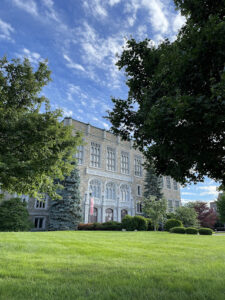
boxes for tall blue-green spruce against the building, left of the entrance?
[49,165,81,230]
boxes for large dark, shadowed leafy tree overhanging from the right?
[108,0,225,184]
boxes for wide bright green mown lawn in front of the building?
[0,231,225,300]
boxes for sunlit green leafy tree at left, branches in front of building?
[0,57,81,197]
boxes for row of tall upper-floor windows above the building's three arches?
[76,142,142,177]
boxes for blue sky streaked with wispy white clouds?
[0,0,218,204]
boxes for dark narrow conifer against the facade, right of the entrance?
[144,166,163,200]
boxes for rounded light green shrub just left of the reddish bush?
[175,206,198,227]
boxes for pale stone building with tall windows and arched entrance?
[28,118,181,230]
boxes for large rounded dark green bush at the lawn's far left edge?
[0,198,32,231]
